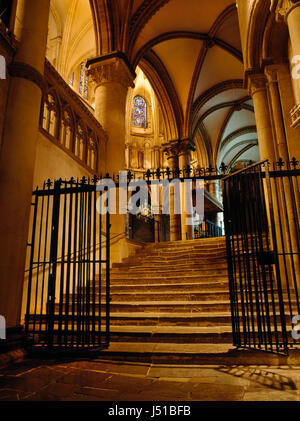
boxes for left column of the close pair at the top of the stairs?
[162,141,181,241]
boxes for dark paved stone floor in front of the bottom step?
[0,359,300,402]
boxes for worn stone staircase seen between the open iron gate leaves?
[101,238,244,361]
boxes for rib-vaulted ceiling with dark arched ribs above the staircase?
[51,0,259,171]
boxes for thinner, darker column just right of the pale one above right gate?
[265,65,289,162]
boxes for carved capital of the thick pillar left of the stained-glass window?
[87,52,136,89]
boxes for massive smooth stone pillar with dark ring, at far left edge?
[0,0,50,328]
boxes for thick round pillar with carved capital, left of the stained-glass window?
[87,52,135,262]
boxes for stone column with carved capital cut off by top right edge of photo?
[276,0,300,127]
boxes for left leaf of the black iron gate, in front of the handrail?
[25,177,110,349]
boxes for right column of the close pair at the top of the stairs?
[179,139,194,240]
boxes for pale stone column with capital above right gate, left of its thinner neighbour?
[248,74,275,162]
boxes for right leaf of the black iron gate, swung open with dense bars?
[224,160,300,354]
